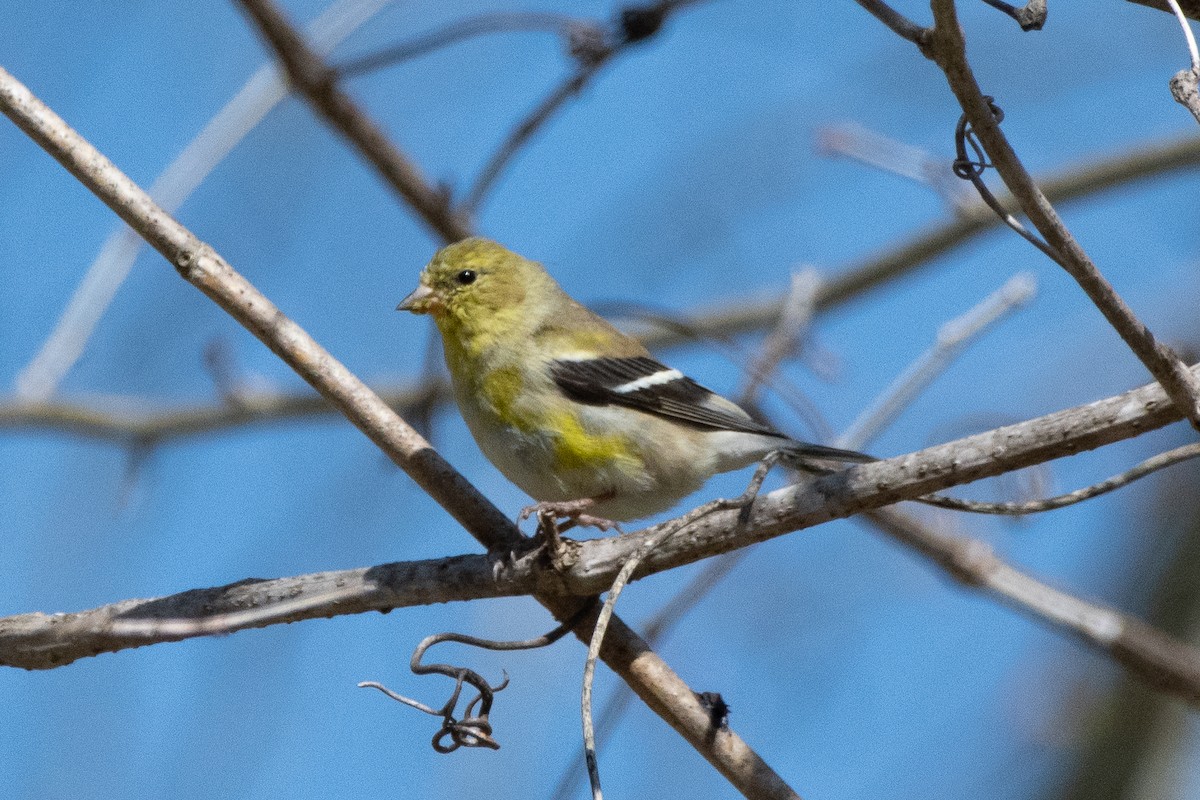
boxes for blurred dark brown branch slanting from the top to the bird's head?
[240,0,472,242]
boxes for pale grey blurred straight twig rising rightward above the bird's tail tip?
[836,272,1037,450]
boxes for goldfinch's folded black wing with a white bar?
[550,356,784,437]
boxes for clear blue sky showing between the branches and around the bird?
[0,0,1200,800]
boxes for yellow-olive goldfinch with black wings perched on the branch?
[397,237,872,527]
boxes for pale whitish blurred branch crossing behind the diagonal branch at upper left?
[16,0,390,401]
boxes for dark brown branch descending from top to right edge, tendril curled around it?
[926,0,1200,429]
